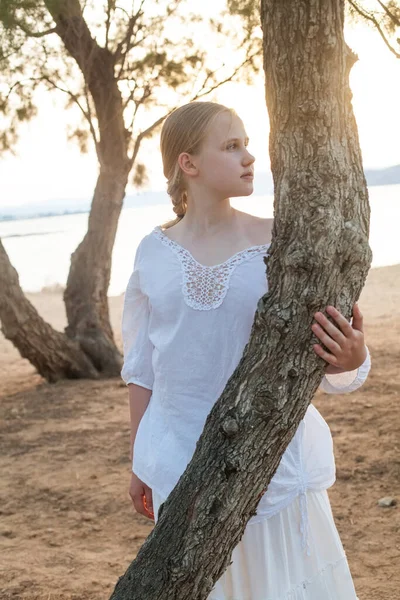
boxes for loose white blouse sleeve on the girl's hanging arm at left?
[121,244,154,390]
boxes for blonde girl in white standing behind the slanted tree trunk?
[122,102,370,600]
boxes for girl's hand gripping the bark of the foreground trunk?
[311,303,367,375]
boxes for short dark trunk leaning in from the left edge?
[0,241,98,382]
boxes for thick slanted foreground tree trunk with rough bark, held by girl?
[111,0,371,600]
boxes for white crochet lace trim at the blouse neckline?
[153,226,270,310]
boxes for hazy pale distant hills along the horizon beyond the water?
[0,165,400,221]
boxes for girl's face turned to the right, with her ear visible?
[182,112,255,199]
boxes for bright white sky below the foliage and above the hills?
[0,7,400,206]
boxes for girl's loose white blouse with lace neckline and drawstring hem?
[121,227,370,543]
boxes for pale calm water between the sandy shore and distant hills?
[0,185,400,296]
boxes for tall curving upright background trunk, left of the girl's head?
[45,0,132,376]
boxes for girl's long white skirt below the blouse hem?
[153,490,357,600]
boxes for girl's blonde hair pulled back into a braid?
[160,102,236,229]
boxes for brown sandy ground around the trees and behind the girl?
[0,265,400,600]
